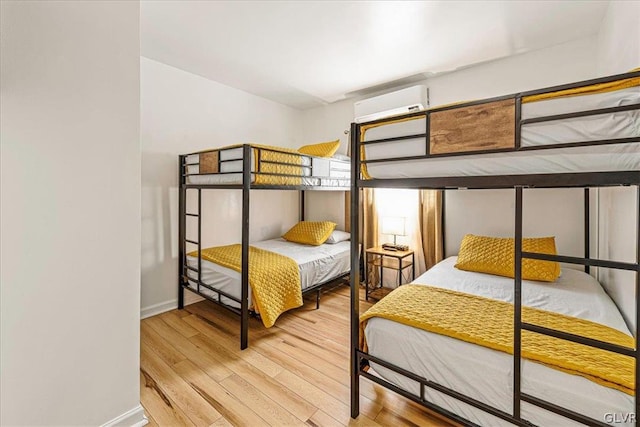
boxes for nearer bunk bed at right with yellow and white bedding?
[350,71,640,426]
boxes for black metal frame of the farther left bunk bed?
[178,144,350,350]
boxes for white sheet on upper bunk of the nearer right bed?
[365,87,640,178]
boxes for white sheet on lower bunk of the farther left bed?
[187,238,351,307]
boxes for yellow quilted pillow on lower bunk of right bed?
[455,234,560,282]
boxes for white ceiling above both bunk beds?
[141,0,608,108]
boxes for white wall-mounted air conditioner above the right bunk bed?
[353,85,429,123]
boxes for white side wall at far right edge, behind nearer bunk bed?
[597,1,640,328]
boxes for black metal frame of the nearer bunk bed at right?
[350,72,640,426]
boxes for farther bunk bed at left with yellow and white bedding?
[178,141,351,349]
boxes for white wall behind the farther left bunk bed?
[140,58,307,316]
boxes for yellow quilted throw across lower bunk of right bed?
[360,285,635,395]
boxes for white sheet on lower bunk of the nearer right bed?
[365,257,634,426]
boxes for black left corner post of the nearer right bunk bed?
[349,123,360,418]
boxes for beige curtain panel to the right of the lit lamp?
[420,190,444,270]
